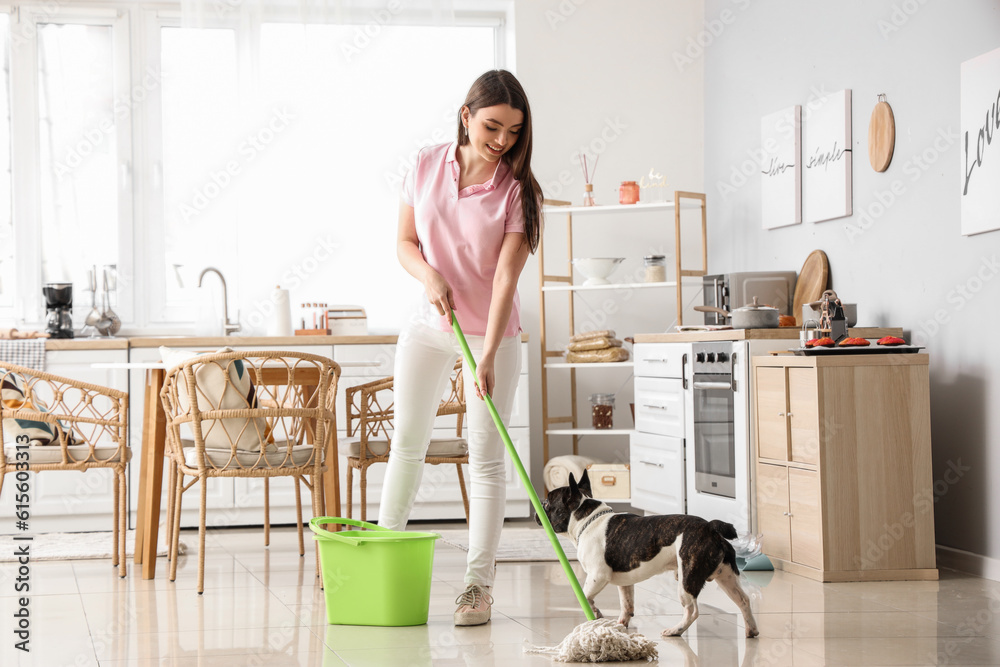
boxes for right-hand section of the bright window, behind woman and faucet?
[151,23,496,333]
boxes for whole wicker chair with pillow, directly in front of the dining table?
[160,351,340,594]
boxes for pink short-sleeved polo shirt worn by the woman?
[401,142,524,336]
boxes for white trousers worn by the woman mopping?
[378,324,521,586]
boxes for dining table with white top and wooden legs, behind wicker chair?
[91,361,379,579]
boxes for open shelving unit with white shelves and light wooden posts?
[538,192,708,496]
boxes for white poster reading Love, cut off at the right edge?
[959,49,1000,236]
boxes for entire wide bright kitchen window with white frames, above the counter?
[0,0,506,333]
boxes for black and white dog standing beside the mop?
[535,472,758,637]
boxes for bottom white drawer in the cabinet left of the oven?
[629,432,684,514]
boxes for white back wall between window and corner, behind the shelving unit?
[513,0,703,498]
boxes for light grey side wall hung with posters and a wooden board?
[704,0,1000,559]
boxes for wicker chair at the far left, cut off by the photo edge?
[0,363,132,577]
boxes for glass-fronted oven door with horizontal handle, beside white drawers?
[692,374,736,498]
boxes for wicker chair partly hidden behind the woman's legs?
[341,359,469,522]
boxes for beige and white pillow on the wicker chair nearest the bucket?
[160,347,270,452]
